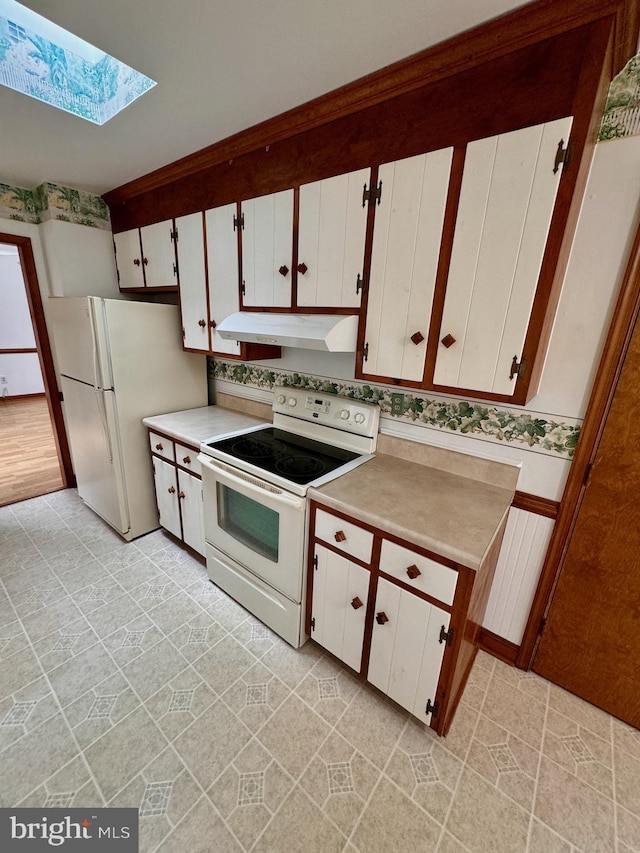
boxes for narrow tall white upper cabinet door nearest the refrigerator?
[176,213,209,352]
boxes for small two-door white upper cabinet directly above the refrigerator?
[113,219,178,290]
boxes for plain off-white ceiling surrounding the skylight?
[0,0,523,193]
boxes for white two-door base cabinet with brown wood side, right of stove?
[306,501,502,735]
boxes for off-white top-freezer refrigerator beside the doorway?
[48,296,207,540]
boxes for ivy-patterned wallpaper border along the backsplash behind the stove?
[208,358,580,459]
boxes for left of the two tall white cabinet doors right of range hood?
[362,148,453,383]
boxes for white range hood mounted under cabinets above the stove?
[216,311,358,352]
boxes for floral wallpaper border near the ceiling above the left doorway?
[0,182,111,231]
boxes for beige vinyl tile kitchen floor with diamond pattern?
[0,490,640,853]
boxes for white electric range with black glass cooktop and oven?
[198,388,380,648]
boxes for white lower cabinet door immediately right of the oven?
[311,545,369,672]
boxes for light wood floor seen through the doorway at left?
[0,395,64,506]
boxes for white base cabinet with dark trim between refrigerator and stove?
[149,430,205,556]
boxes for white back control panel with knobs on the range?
[273,386,380,437]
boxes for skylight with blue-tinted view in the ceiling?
[0,0,156,124]
